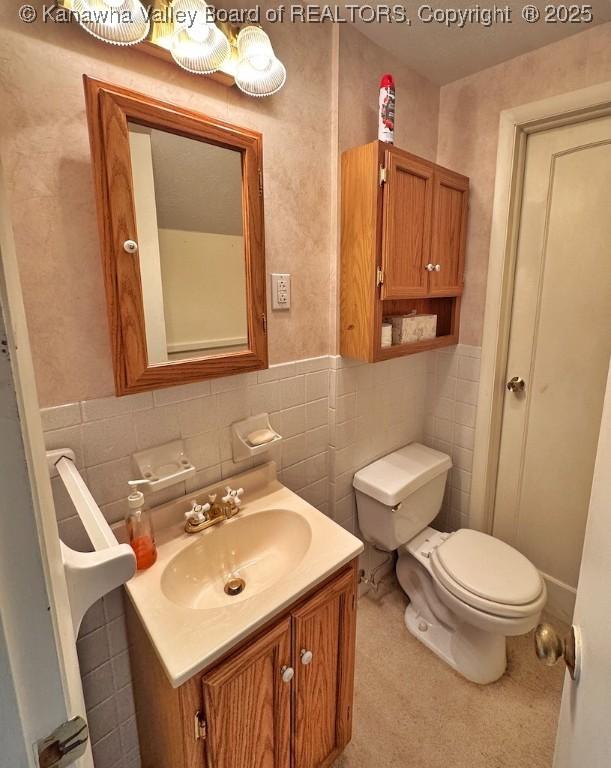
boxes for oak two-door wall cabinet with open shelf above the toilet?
[340,141,469,362]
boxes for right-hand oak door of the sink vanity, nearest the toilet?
[293,569,356,768]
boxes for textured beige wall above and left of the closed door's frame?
[437,24,611,345]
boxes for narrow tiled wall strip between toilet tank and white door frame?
[424,344,481,531]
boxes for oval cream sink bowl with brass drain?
[161,509,312,610]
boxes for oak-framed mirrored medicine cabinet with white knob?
[85,77,267,394]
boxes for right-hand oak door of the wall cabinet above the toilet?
[429,168,469,296]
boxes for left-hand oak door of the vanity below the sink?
[202,618,293,768]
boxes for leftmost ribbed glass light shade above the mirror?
[72,0,151,45]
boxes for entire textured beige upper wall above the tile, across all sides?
[7,14,611,405]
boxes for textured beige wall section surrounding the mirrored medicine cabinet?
[0,13,332,406]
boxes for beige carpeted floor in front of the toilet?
[334,584,564,768]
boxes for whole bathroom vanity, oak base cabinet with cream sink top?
[127,464,363,768]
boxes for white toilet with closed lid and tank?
[354,443,547,684]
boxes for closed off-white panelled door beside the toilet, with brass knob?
[493,117,611,622]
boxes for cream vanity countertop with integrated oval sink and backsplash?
[126,462,363,688]
